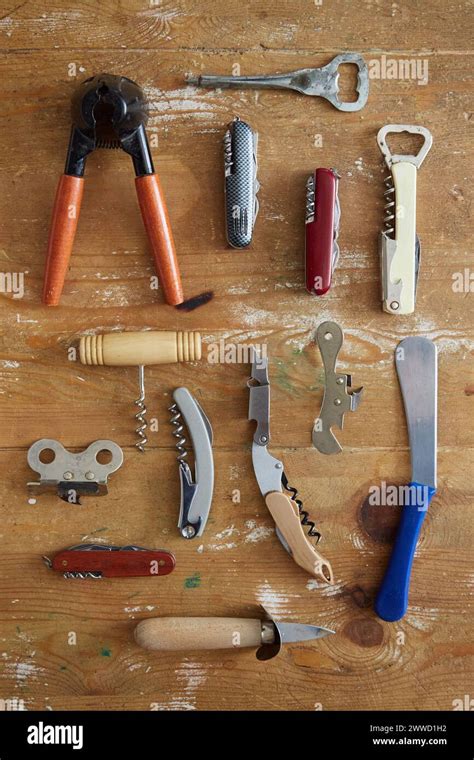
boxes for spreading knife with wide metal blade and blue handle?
[375,337,438,622]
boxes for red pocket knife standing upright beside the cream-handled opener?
[306,169,341,296]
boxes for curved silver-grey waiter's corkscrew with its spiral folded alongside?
[169,388,214,538]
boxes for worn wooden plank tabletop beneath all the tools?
[0,0,474,710]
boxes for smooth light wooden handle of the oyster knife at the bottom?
[135,617,270,652]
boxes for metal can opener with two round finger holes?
[27,438,123,504]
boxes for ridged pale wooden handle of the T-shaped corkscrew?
[79,330,201,367]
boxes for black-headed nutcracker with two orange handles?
[43,74,184,306]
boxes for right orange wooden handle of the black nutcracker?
[135,174,184,306]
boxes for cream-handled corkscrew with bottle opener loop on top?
[377,124,433,314]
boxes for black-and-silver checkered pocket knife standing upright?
[224,116,260,248]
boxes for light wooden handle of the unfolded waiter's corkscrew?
[265,491,334,583]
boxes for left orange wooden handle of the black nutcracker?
[43,174,84,306]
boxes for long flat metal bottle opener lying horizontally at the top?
[187,53,369,111]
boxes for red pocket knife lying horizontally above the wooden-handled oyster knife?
[43,544,175,578]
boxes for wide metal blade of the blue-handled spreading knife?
[395,337,438,488]
